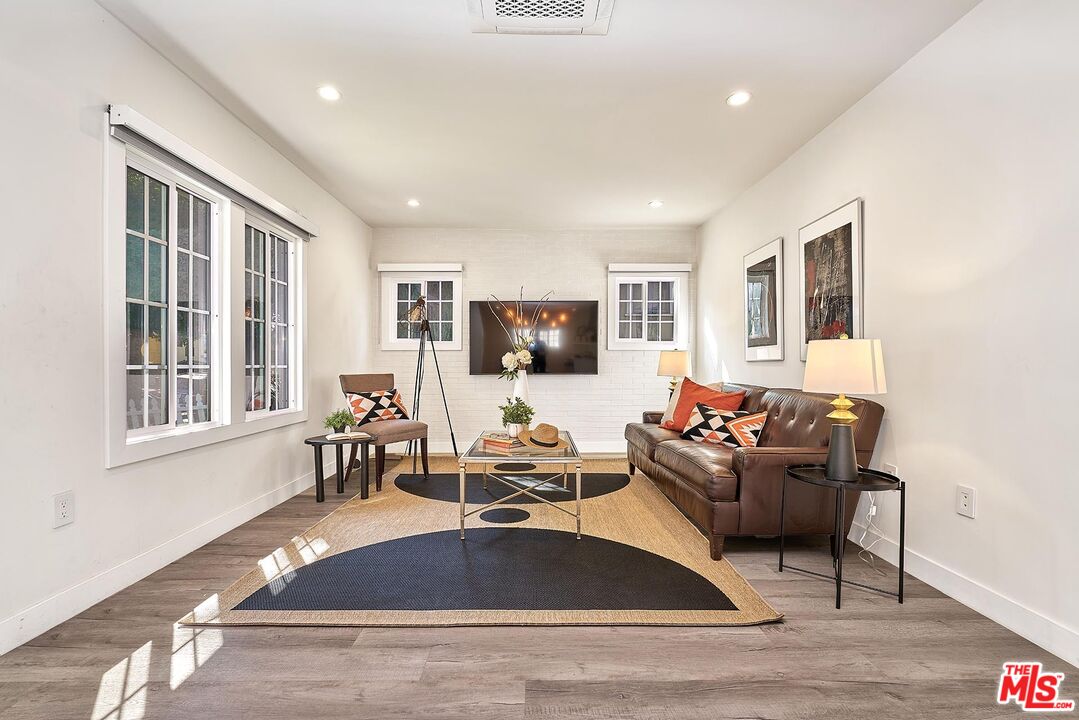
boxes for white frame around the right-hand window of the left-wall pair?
[236,213,303,421]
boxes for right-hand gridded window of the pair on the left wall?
[244,218,298,413]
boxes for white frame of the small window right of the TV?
[607,263,692,350]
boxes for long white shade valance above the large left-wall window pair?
[109,105,318,237]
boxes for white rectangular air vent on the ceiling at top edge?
[468,0,614,35]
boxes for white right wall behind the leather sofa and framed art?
[697,0,1079,664]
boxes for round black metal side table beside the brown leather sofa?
[779,465,906,610]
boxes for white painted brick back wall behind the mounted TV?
[366,228,696,452]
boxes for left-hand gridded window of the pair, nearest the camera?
[124,155,221,439]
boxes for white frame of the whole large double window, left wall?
[103,119,308,467]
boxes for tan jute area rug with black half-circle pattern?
[180,458,781,627]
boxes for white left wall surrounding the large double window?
[0,0,373,652]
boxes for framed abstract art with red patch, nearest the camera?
[798,199,862,359]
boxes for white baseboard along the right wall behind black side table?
[849,522,1079,665]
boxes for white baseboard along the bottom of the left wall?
[0,463,336,655]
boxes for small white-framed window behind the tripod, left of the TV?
[379,263,463,350]
